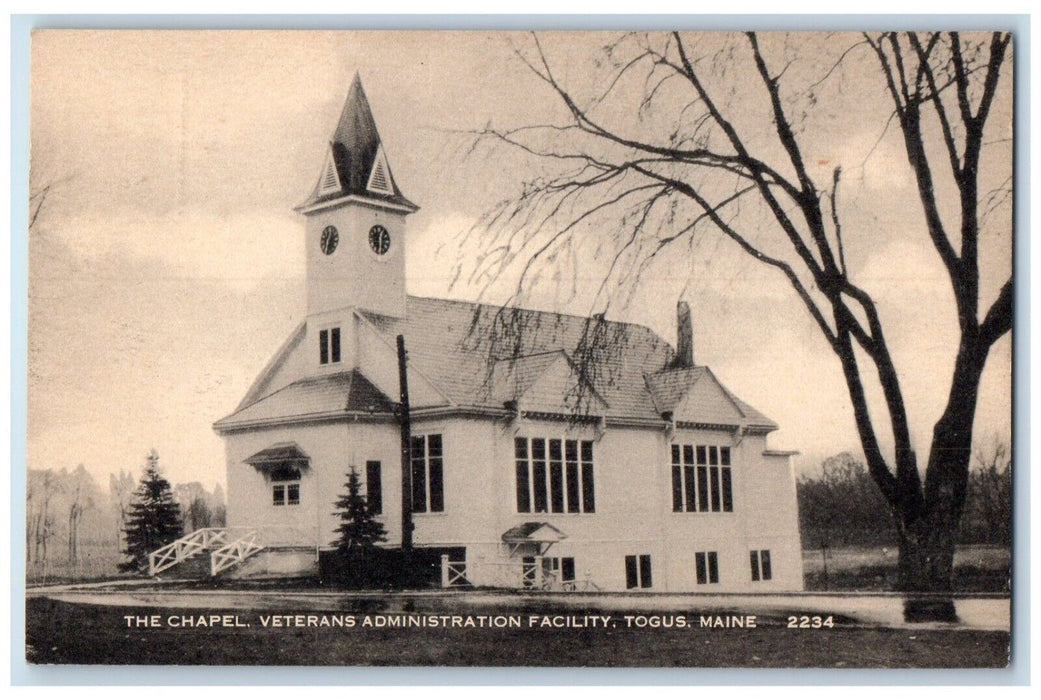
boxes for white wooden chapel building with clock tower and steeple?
[205,77,803,593]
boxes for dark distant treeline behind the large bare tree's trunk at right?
[797,441,1012,549]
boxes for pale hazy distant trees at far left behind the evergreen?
[25,465,225,573]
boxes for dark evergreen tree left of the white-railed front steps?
[120,450,182,571]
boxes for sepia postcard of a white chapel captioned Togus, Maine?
[24,26,1016,669]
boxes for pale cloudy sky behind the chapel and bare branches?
[28,31,1011,484]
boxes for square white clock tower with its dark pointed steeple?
[297,75,418,320]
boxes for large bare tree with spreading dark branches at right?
[471,32,1013,617]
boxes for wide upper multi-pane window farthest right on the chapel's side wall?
[672,445,734,513]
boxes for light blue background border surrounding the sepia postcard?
[10,15,1031,685]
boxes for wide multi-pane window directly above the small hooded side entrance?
[513,438,596,513]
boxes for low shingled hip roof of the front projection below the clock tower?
[213,370,395,430]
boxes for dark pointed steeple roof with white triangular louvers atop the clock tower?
[298,73,418,211]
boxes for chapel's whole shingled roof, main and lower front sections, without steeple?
[214,296,777,431]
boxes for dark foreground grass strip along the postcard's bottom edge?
[26,598,1009,668]
